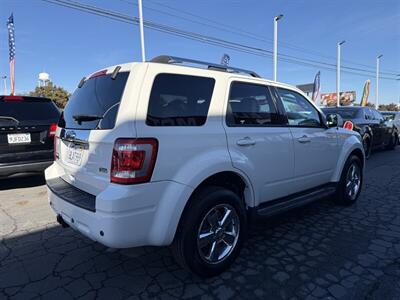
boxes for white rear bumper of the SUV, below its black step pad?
[46,165,193,248]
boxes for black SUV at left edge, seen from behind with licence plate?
[0,96,60,177]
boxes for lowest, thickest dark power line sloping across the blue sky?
[42,0,396,80]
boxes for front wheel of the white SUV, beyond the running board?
[334,155,363,206]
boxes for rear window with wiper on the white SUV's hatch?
[59,72,129,129]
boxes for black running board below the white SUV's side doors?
[250,184,336,218]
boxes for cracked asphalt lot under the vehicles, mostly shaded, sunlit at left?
[0,147,400,300]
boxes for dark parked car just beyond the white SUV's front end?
[322,106,399,157]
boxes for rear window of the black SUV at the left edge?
[0,98,60,126]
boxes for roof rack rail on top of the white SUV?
[150,55,260,78]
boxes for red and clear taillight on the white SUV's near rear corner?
[111,138,158,184]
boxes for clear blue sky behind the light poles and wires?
[0,0,400,103]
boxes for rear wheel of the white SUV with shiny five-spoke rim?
[172,186,247,277]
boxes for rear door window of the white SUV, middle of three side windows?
[226,82,279,126]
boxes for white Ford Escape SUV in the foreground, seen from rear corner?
[46,56,364,276]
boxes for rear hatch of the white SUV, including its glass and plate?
[55,67,134,195]
